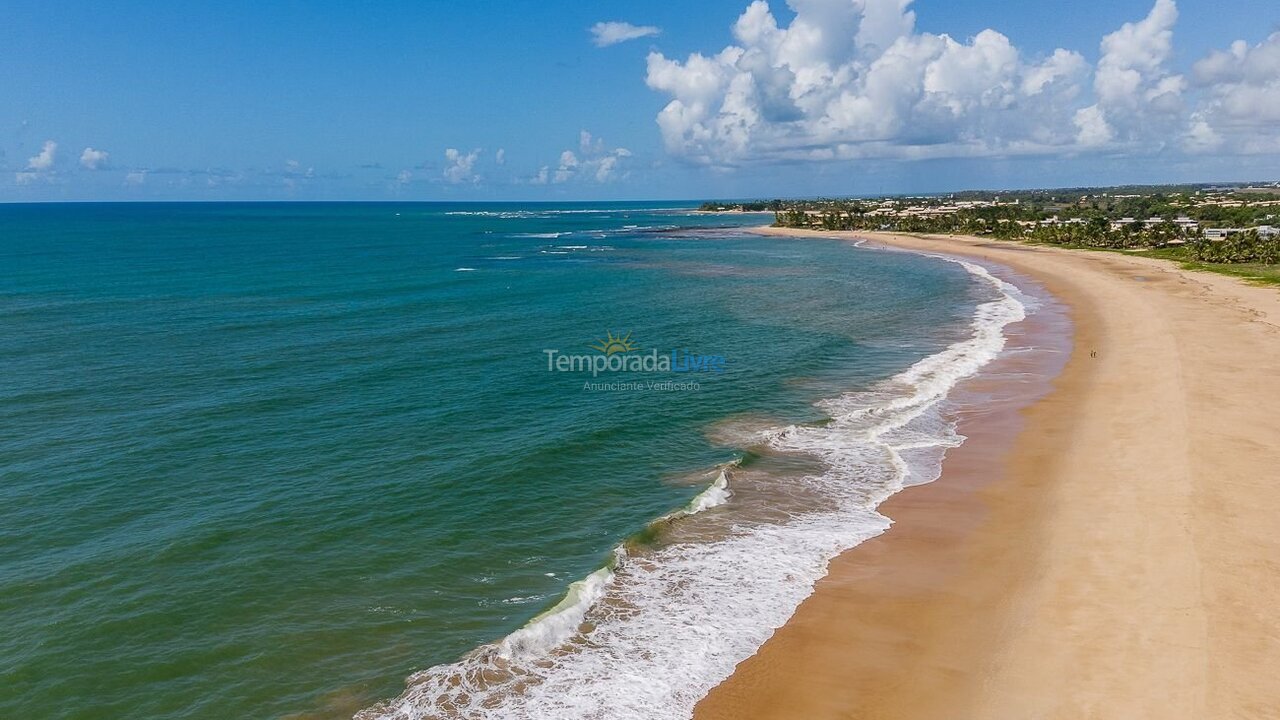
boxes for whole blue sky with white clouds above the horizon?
[0,0,1280,202]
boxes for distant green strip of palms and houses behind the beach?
[701,182,1280,265]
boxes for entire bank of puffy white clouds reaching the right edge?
[645,0,1280,168]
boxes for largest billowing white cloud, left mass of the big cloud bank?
[646,0,1088,165]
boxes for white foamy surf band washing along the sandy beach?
[360,248,1027,720]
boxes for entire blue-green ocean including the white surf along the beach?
[0,202,1025,720]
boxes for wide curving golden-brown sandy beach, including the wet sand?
[696,228,1280,720]
